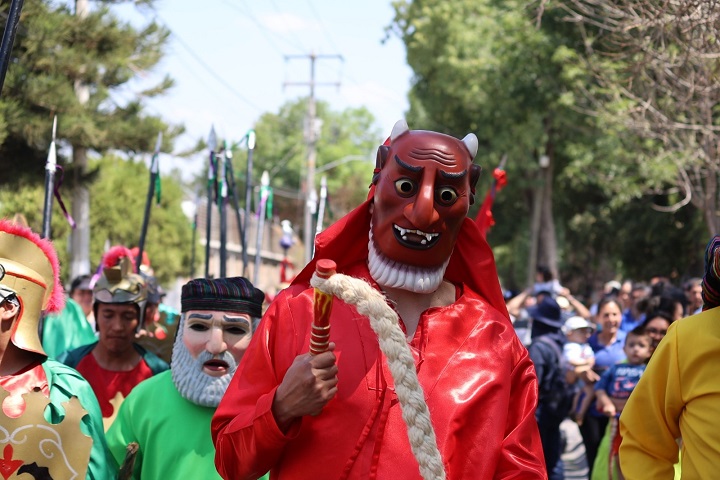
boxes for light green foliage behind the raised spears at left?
[0,156,192,285]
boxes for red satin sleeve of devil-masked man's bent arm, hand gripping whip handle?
[212,290,304,480]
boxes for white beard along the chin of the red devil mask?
[368,224,450,293]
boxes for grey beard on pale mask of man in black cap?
[170,315,238,407]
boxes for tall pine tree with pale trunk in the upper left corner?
[0,0,182,273]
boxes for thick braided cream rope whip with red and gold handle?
[310,259,445,480]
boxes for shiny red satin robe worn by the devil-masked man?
[212,262,547,480]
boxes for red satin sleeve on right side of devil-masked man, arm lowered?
[495,342,547,480]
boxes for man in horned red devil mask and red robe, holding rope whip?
[212,121,546,480]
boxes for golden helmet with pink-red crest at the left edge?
[0,220,65,355]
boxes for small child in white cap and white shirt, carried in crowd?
[562,316,595,425]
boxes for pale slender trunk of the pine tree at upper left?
[70,0,90,278]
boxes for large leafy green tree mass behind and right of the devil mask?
[390,0,701,293]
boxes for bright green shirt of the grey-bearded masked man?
[106,371,266,480]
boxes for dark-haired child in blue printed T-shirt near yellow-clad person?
[592,327,652,479]
